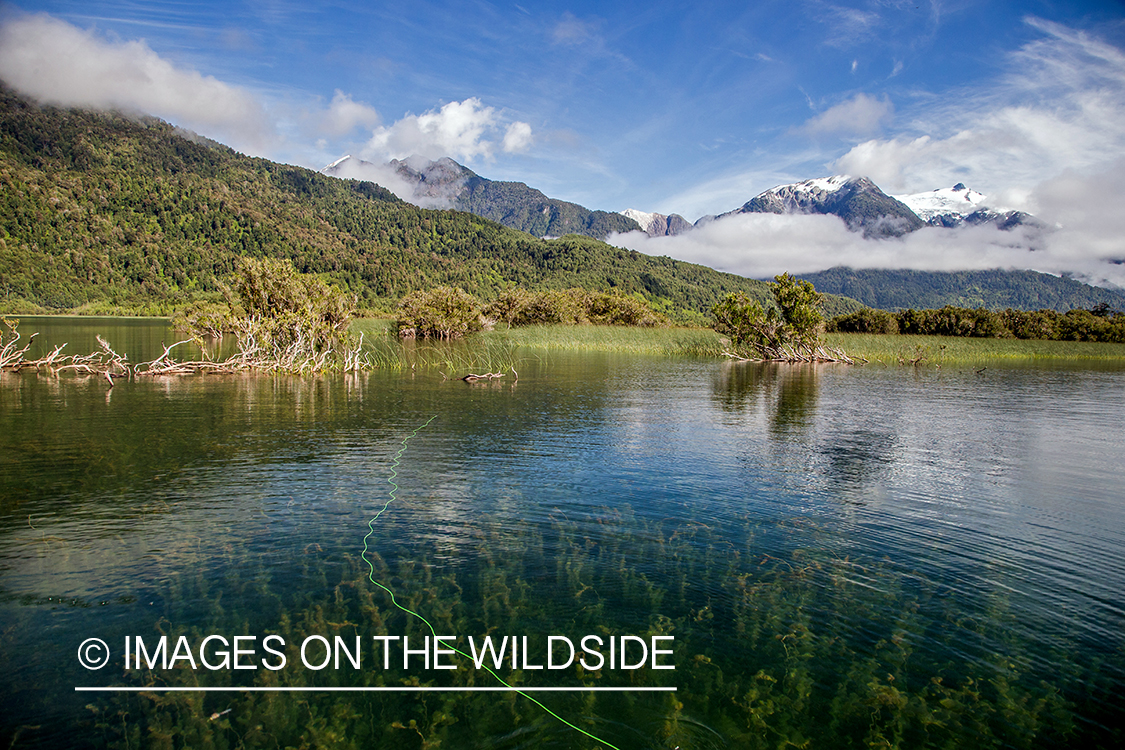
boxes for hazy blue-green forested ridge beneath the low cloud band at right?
[803,266,1125,313]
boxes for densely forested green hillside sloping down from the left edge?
[0,87,861,322]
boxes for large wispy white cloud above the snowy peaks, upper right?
[834,18,1125,197]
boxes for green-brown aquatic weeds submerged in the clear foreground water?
[85,508,1119,748]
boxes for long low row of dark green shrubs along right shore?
[828,305,1125,343]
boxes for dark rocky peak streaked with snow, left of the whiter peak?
[718,174,925,237]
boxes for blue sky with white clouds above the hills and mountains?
[0,0,1125,284]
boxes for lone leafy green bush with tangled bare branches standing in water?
[711,273,854,364]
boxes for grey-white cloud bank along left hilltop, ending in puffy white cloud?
[0,11,533,169]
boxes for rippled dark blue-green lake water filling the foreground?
[0,318,1125,750]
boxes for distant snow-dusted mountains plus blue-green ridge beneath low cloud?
[322,157,1125,311]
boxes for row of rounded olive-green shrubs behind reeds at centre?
[396,287,668,338]
